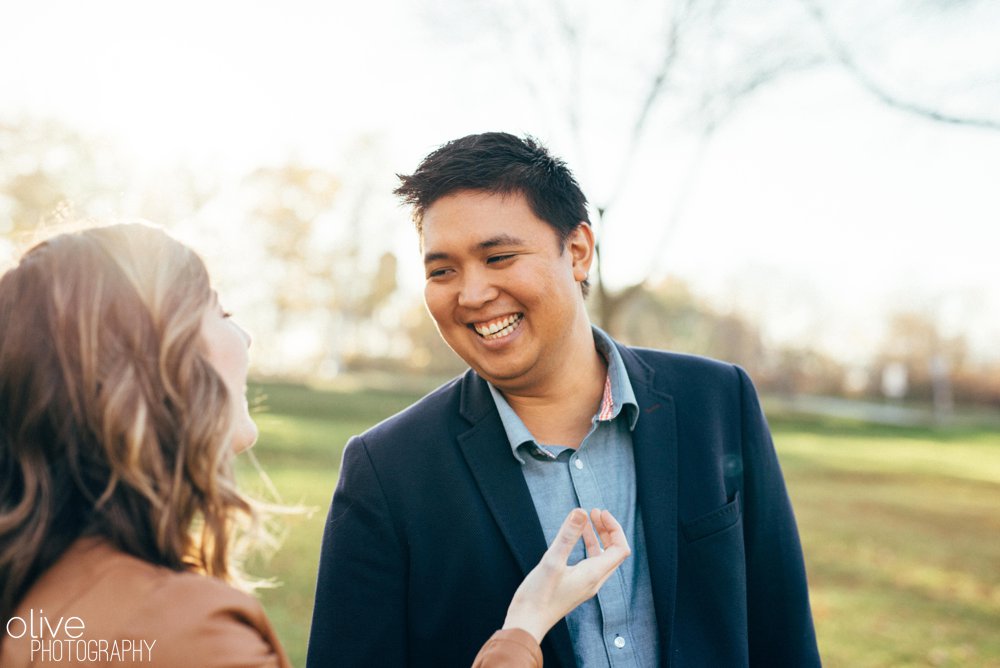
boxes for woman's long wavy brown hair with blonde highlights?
[0,224,256,619]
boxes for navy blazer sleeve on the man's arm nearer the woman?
[306,436,407,668]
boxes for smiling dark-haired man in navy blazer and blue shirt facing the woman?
[309,133,819,666]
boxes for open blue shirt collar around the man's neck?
[486,325,639,464]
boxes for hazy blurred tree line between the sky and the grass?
[0,115,1000,408]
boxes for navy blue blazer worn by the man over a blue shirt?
[307,346,820,668]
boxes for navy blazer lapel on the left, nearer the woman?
[458,371,576,666]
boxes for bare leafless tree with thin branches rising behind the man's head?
[420,0,1000,332]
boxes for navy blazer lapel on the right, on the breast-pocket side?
[618,345,678,665]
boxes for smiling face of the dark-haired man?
[423,190,593,391]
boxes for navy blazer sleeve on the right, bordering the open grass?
[737,369,820,666]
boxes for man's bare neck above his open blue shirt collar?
[501,325,608,448]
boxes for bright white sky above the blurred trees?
[0,0,1000,358]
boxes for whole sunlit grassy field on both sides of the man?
[241,385,1000,668]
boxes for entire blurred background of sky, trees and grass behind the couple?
[0,0,1000,666]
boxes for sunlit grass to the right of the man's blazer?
[775,420,1000,667]
